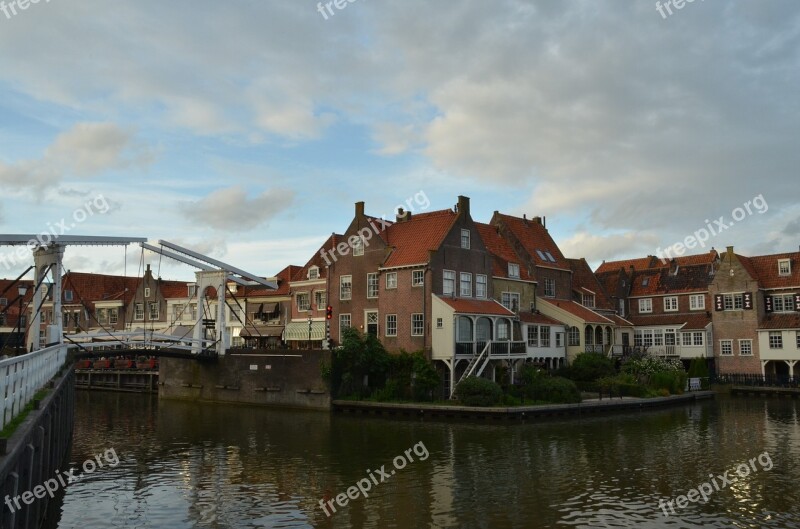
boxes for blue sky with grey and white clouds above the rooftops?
[0,0,800,280]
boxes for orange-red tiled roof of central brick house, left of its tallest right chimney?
[383,209,458,268]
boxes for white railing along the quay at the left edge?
[0,344,69,428]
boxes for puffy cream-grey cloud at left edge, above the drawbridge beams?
[0,123,153,190]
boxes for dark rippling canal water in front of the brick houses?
[48,392,800,529]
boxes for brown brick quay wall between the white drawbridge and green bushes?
[158,349,331,410]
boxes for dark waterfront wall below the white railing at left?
[0,366,75,529]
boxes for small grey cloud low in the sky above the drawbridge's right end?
[180,186,294,232]
